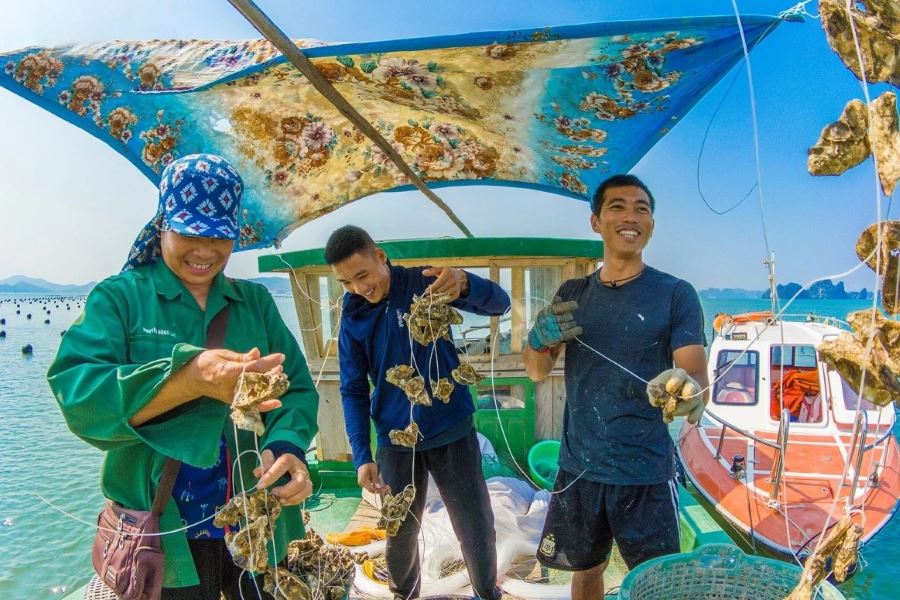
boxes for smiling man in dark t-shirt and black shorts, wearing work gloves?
[525,175,708,600]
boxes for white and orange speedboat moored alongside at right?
[676,313,900,556]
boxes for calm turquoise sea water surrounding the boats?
[0,294,900,600]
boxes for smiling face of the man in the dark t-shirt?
[591,185,653,259]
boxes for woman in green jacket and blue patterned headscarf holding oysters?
[48,154,318,600]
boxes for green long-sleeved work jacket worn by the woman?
[47,260,319,587]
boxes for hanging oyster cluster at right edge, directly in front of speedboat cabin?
[818,308,900,406]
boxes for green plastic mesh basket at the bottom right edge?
[619,544,844,600]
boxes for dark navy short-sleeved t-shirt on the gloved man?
[558,267,706,485]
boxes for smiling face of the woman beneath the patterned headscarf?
[161,231,234,296]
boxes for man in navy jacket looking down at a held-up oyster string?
[325,225,510,600]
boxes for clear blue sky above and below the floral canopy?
[0,0,887,290]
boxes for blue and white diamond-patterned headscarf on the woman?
[122,154,244,271]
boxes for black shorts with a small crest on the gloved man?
[537,469,681,571]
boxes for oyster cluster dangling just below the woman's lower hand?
[213,490,281,572]
